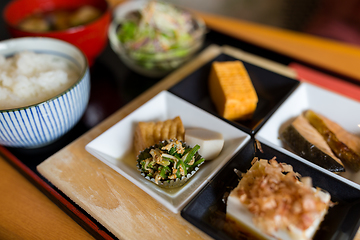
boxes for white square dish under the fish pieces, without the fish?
[255,82,360,189]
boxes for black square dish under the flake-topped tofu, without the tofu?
[181,140,360,240]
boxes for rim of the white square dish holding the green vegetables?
[85,91,250,213]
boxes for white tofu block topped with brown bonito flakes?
[226,159,331,240]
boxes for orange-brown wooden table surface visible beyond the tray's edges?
[0,1,360,239]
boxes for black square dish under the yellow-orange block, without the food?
[169,54,299,134]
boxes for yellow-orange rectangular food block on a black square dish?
[209,61,258,120]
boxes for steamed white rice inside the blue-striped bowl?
[0,51,79,109]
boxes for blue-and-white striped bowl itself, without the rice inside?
[0,37,90,148]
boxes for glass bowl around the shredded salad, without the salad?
[108,0,206,78]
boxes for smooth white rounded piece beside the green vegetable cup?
[185,128,224,160]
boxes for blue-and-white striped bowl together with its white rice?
[0,37,90,148]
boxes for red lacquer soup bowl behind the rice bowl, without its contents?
[3,0,111,65]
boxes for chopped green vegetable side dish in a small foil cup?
[137,140,205,188]
